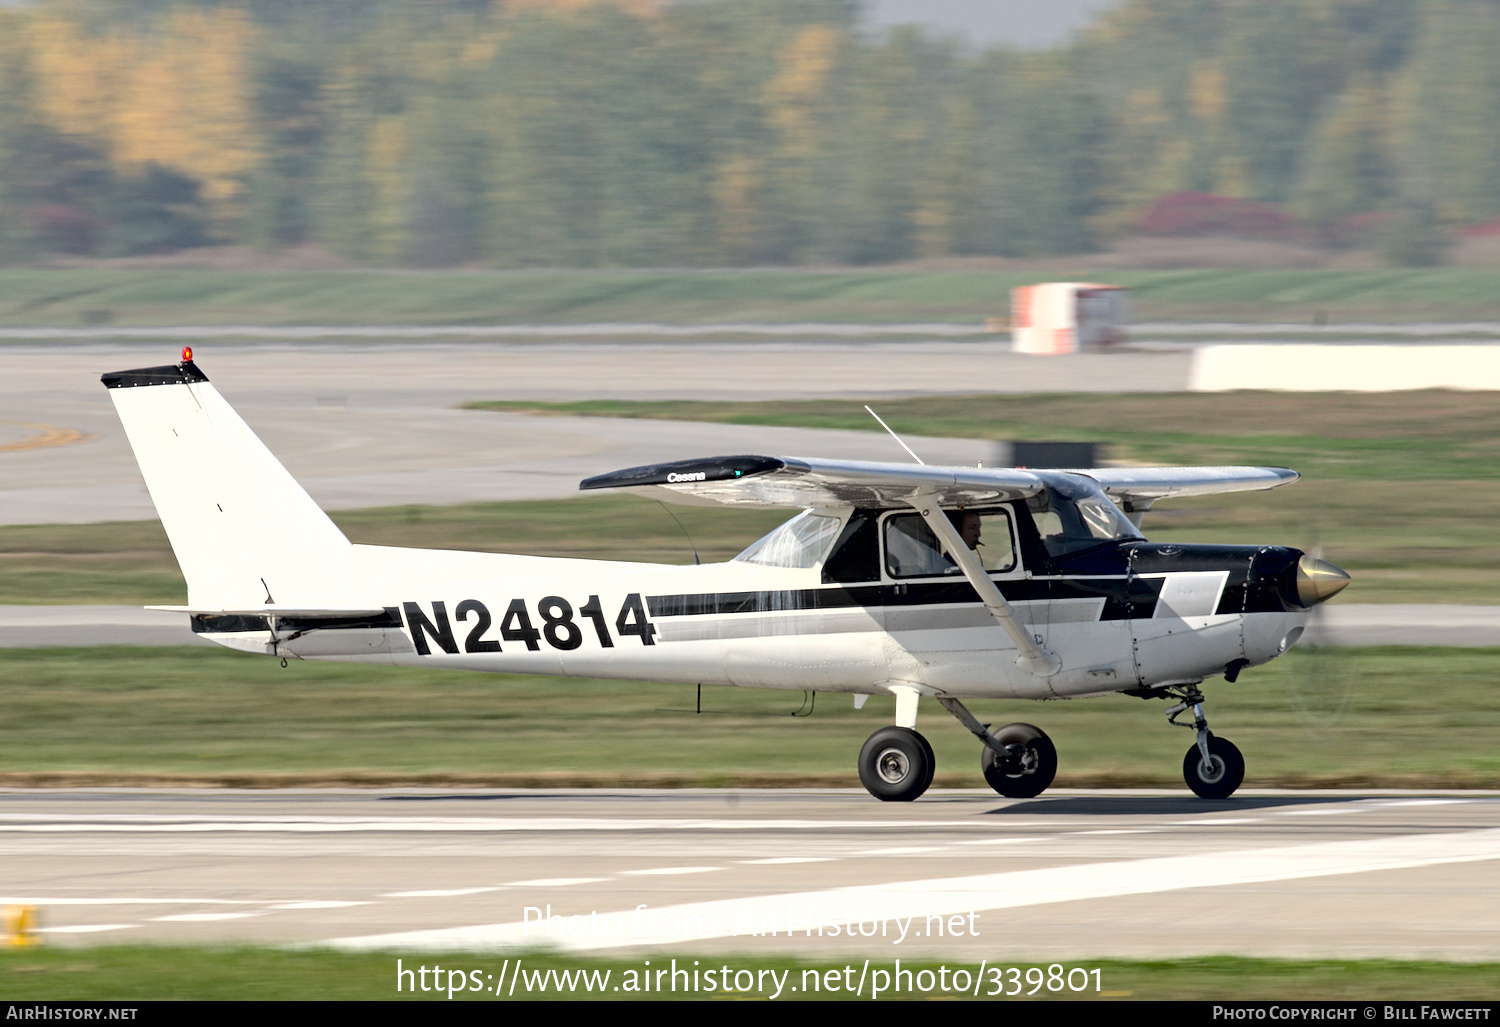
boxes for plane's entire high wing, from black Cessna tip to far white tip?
[579,456,1298,510]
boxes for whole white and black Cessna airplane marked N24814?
[104,351,1349,799]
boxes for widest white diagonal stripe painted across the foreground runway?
[326,828,1500,951]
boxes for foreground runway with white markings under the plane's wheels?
[0,790,1500,966]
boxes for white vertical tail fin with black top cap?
[102,360,350,609]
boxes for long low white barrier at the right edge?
[1188,345,1500,393]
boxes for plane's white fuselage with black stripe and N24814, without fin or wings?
[194,513,1308,699]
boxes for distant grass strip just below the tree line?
[0,266,1500,325]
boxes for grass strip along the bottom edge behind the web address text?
[0,945,1500,1002]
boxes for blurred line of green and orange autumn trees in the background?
[0,0,1500,267]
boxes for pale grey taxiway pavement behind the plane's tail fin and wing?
[0,339,1191,525]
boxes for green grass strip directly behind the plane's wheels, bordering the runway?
[0,646,1500,787]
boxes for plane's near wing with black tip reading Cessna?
[579,456,1047,510]
